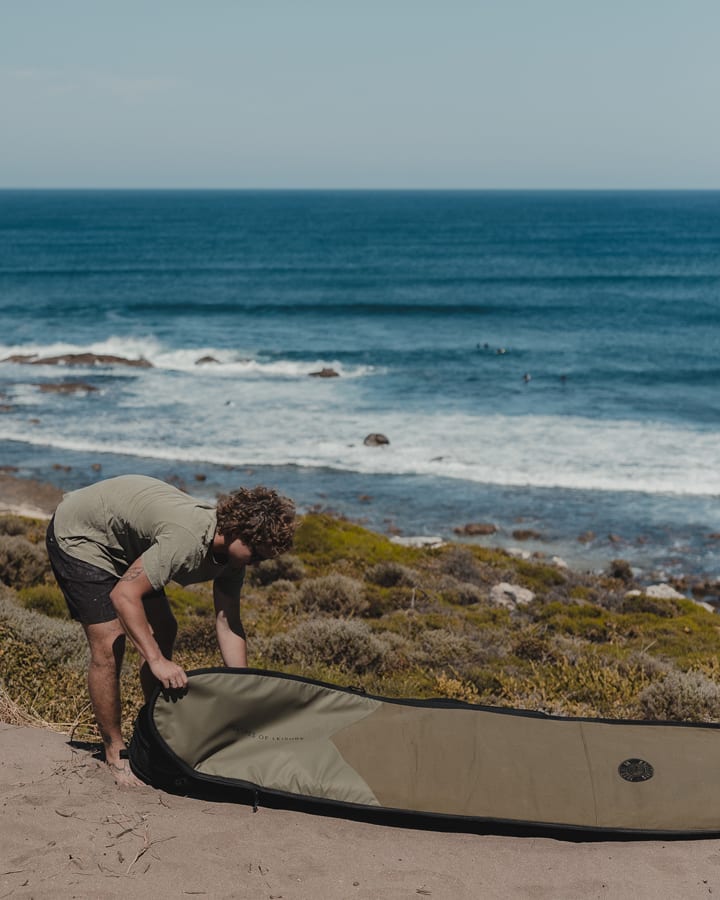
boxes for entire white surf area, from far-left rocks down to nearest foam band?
[0,337,720,495]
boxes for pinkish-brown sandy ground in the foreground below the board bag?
[0,725,720,900]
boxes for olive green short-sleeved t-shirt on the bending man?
[54,475,245,596]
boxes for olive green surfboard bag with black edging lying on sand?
[130,669,720,835]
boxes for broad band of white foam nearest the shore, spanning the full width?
[5,401,720,495]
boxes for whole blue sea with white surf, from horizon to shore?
[0,191,720,577]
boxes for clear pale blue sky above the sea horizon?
[0,0,720,189]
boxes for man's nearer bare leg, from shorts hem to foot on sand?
[83,619,142,786]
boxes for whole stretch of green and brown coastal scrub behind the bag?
[0,515,720,736]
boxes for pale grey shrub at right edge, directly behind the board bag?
[639,671,720,722]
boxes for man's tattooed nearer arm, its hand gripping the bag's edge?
[110,559,187,688]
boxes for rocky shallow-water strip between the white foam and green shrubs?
[0,458,720,585]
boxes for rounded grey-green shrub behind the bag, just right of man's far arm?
[265,619,387,673]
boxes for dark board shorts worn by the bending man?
[45,519,119,625]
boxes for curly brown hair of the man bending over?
[217,485,297,556]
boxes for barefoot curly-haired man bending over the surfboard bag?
[47,475,295,785]
